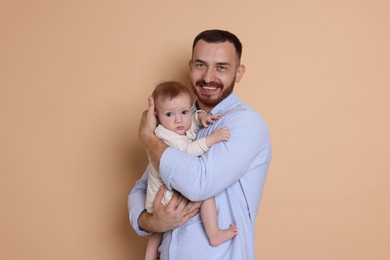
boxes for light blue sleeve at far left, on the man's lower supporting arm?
[127,164,151,236]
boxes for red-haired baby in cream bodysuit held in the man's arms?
[145,81,238,260]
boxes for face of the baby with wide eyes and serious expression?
[155,94,193,135]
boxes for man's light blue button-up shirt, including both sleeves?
[128,93,271,260]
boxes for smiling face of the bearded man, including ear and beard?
[189,40,245,112]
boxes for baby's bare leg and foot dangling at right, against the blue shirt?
[200,198,238,246]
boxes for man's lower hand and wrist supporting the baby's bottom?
[138,187,202,232]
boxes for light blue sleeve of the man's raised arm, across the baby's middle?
[160,106,271,201]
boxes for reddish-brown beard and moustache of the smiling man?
[192,78,235,107]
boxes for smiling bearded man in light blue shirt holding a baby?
[129,30,271,260]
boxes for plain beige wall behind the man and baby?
[0,0,390,260]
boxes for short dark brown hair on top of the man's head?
[192,29,242,61]
